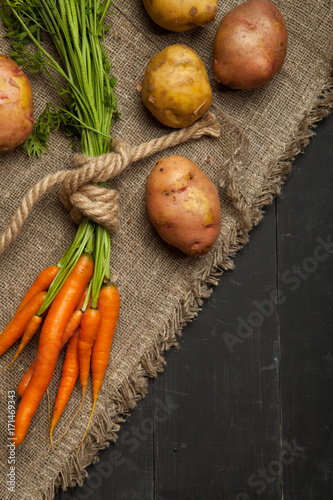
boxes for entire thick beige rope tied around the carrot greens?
[0,112,220,254]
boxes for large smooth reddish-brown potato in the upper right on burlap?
[213,0,287,89]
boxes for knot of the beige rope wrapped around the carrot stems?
[60,139,132,231]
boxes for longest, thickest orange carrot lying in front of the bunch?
[14,253,94,446]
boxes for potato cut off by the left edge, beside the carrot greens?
[0,55,34,151]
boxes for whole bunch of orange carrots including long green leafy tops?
[0,0,119,445]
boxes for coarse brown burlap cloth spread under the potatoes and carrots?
[0,0,333,500]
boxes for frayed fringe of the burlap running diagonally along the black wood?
[42,64,333,500]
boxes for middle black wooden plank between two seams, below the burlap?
[154,201,281,500]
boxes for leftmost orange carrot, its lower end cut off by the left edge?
[0,292,46,355]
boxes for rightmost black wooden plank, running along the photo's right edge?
[278,111,333,500]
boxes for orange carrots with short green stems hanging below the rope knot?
[0,221,120,446]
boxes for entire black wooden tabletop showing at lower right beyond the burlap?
[56,115,333,500]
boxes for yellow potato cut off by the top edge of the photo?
[143,0,219,31]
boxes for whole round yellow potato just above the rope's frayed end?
[141,44,212,128]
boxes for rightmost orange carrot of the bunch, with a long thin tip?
[77,282,120,453]
